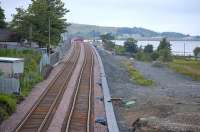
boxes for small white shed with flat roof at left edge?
[0,57,24,77]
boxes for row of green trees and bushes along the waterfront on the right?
[101,33,200,62]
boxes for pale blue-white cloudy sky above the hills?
[0,0,200,35]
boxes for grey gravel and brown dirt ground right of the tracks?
[99,50,200,132]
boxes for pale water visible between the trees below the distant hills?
[114,40,200,55]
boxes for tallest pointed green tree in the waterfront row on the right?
[157,38,172,62]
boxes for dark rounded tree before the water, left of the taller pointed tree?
[124,38,138,53]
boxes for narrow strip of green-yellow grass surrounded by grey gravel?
[123,62,154,86]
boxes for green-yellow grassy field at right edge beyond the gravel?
[169,58,200,80]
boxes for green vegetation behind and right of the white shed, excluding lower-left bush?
[0,49,42,96]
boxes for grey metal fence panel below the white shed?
[0,78,20,93]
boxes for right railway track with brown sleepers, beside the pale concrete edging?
[62,45,94,132]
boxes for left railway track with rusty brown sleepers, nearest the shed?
[14,45,81,132]
